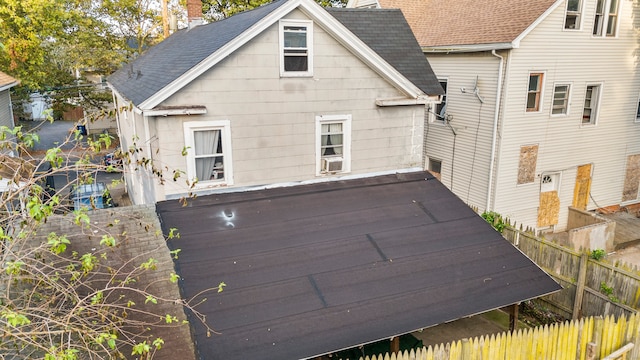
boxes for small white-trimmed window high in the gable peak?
[280,20,313,76]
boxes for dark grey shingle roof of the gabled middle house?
[108,0,442,106]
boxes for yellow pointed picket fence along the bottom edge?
[360,314,640,360]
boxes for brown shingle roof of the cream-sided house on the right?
[379,0,556,47]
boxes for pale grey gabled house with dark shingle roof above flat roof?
[108,0,443,204]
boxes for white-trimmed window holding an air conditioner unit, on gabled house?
[316,115,351,175]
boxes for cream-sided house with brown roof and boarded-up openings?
[349,0,640,231]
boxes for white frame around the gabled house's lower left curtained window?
[183,120,233,188]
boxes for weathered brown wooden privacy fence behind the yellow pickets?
[502,226,640,319]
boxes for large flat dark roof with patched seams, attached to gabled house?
[157,172,560,360]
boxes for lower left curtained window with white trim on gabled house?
[184,120,233,185]
